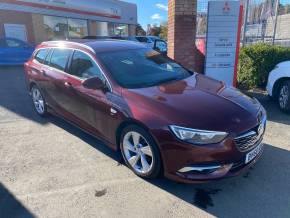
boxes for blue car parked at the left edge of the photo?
[0,38,34,65]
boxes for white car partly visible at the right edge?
[267,61,290,112]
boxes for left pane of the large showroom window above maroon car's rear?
[43,16,68,40]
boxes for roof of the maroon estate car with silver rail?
[41,39,147,53]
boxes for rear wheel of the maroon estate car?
[31,85,47,117]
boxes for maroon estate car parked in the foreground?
[25,40,266,182]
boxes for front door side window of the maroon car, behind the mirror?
[69,51,105,81]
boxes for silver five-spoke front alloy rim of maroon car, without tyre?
[122,131,154,175]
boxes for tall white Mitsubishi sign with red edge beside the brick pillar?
[205,1,243,86]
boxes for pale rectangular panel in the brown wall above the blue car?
[4,23,27,42]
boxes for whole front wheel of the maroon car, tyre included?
[120,125,161,179]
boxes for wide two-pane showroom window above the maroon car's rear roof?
[43,16,88,40]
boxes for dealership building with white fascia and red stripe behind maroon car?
[0,0,137,44]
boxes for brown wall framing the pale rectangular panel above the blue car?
[0,10,35,43]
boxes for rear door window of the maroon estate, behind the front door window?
[49,48,71,71]
